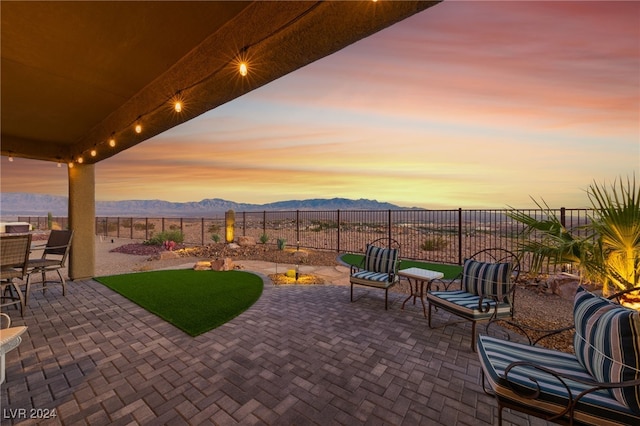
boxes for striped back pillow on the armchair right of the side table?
[462,259,511,302]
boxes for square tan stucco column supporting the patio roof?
[69,164,96,280]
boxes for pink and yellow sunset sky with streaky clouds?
[1,1,640,209]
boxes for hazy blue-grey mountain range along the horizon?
[0,192,403,217]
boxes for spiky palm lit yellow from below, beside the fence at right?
[507,175,640,293]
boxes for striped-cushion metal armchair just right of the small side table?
[427,248,520,351]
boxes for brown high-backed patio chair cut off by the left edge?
[0,234,31,316]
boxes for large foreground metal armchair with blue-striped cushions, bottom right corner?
[478,287,640,425]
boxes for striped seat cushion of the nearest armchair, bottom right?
[477,335,640,425]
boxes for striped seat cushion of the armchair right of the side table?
[427,290,511,320]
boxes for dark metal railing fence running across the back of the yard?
[19,208,590,270]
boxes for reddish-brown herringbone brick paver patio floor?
[0,274,546,426]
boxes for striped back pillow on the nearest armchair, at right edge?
[573,287,640,414]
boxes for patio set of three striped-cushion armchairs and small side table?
[350,239,640,425]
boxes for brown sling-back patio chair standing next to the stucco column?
[25,230,73,304]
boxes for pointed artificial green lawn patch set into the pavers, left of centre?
[96,269,263,336]
